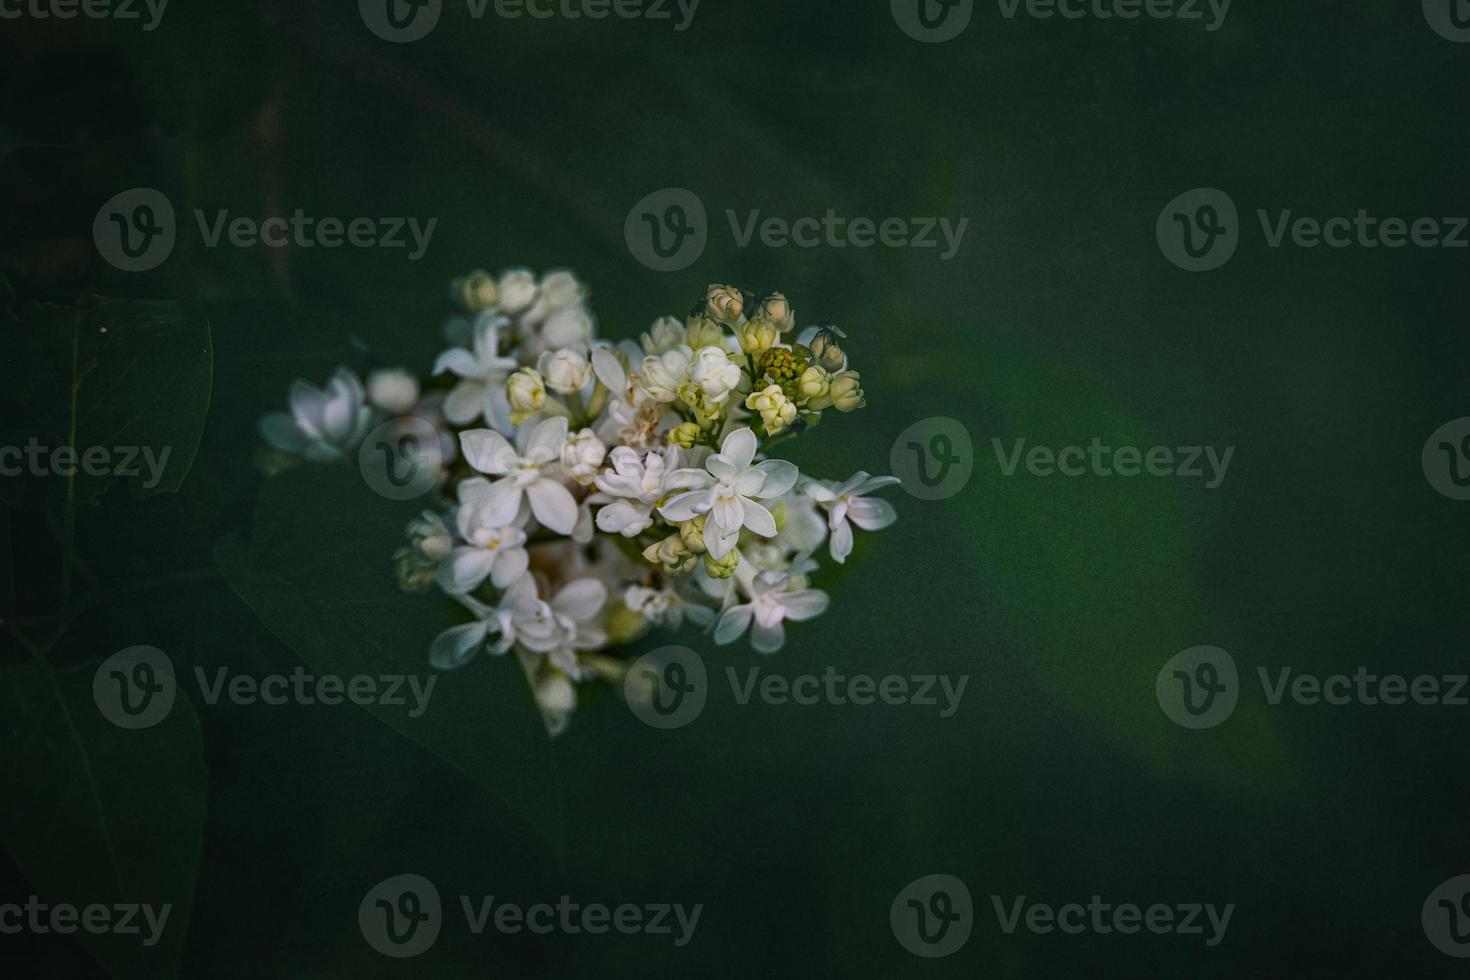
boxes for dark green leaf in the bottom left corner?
[0,660,206,980]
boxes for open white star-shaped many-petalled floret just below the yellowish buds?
[659,428,798,560]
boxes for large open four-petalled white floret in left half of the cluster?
[460,416,576,535]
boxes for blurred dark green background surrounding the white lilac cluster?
[0,0,1470,977]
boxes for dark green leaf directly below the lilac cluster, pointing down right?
[215,466,563,851]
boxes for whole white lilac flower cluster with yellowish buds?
[260,269,898,733]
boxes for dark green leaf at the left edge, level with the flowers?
[0,294,213,508]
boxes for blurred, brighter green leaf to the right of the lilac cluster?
[935,356,1291,792]
